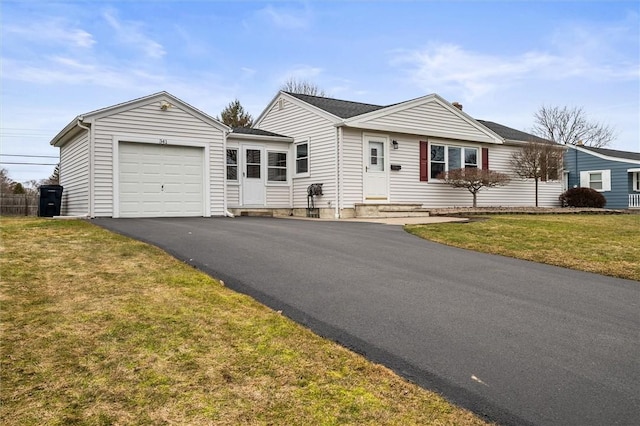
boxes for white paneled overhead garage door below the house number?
[118,142,204,217]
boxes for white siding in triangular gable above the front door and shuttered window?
[361,100,495,142]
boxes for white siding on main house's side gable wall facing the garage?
[259,98,336,208]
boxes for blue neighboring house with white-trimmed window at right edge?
[564,145,640,209]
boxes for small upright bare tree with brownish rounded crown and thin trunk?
[511,142,565,207]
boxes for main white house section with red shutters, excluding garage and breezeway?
[254,92,562,217]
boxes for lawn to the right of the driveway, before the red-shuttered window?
[405,214,640,281]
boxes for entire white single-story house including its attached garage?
[51,92,562,218]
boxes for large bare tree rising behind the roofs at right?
[532,105,616,148]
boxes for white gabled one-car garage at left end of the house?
[51,92,231,217]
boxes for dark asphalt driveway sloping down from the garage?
[94,218,640,426]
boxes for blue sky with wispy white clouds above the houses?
[0,0,640,182]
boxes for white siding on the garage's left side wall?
[60,131,89,216]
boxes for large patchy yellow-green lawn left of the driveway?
[0,218,490,425]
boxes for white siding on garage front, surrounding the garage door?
[92,100,225,216]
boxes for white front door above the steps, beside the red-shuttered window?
[364,135,389,202]
